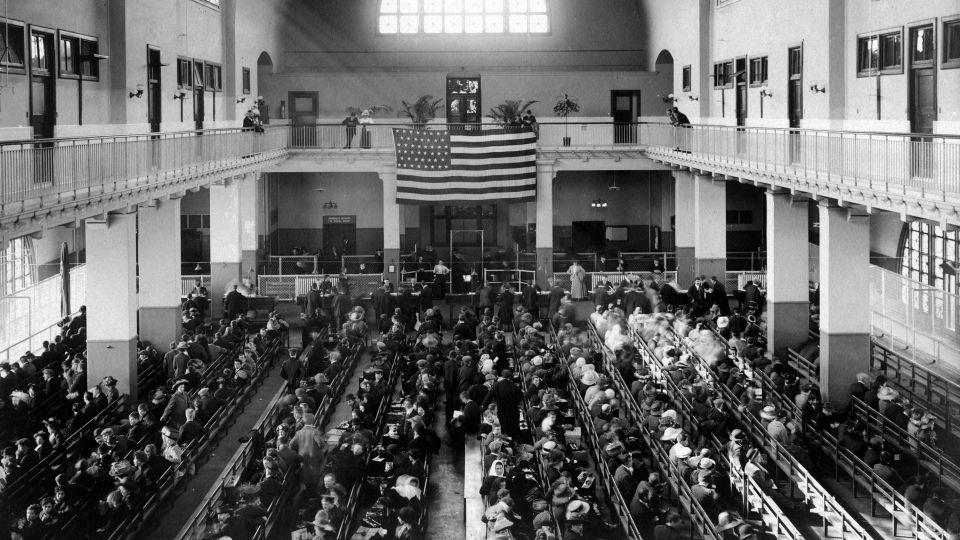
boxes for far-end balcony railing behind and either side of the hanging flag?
[291,122,643,151]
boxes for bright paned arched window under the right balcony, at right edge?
[900,221,960,293]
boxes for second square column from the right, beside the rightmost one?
[766,191,810,355]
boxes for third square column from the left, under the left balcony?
[210,178,244,304]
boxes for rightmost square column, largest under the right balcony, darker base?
[820,203,870,406]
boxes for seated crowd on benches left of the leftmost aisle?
[0,304,279,540]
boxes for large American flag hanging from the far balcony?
[393,128,537,204]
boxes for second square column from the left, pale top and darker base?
[137,198,182,351]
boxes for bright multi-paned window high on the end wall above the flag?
[377,0,550,34]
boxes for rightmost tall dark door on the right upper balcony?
[909,24,937,178]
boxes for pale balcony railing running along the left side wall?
[0,127,290,210]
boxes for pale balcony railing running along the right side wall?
[640,124,960,196]
